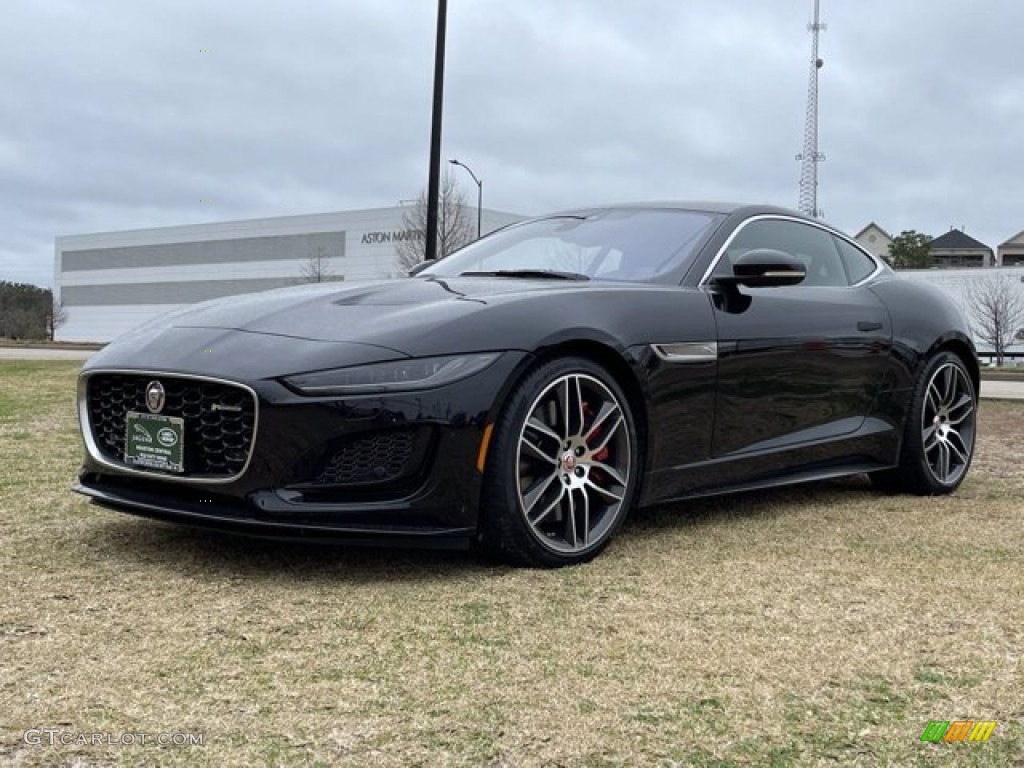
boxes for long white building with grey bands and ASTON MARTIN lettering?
[53,206,523,341]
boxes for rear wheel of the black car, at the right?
[870,352,978,496]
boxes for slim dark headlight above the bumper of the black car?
[285,352,500,395]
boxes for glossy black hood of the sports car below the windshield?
[86,276,664,379]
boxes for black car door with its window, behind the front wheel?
[706,216,892,460]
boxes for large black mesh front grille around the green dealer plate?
[86,374,256,477]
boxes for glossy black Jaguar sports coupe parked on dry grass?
[75,204,978,566]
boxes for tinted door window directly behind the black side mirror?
[715,219,850,286]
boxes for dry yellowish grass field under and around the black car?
[0,361,1024,768]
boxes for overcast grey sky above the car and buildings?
[0,0,1024,287]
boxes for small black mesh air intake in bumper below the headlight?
[314,429,417,485]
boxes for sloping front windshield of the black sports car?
[420,209,721,282]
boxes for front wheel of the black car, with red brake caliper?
[481,357,640,567]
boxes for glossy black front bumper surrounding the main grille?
[73,352,527,547]
